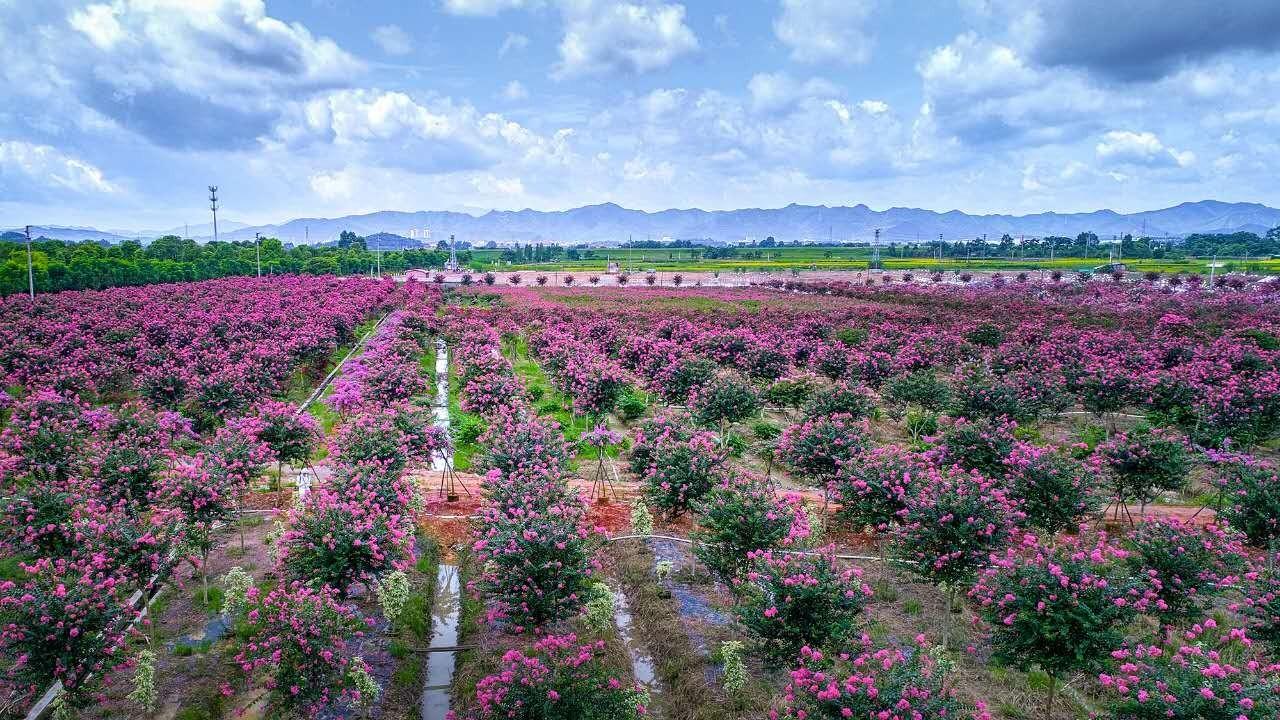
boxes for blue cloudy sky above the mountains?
[0,0,1280,229]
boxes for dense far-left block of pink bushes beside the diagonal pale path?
[0,275,399,428]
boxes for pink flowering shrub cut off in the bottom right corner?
[1098,619,1280,720]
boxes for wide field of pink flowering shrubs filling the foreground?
[0,270,1280,720]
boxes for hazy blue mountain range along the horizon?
[5,200,1280,245]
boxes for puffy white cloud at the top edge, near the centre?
[554,0,698,78]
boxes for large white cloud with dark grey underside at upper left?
[50,0,364,149]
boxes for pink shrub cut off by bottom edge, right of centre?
[769,635,961,720]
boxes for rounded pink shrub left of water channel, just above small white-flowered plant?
[278,489,413,596]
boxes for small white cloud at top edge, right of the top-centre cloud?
[773,0,876,65]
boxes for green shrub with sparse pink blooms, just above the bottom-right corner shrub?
[1125,518,1247,624]
